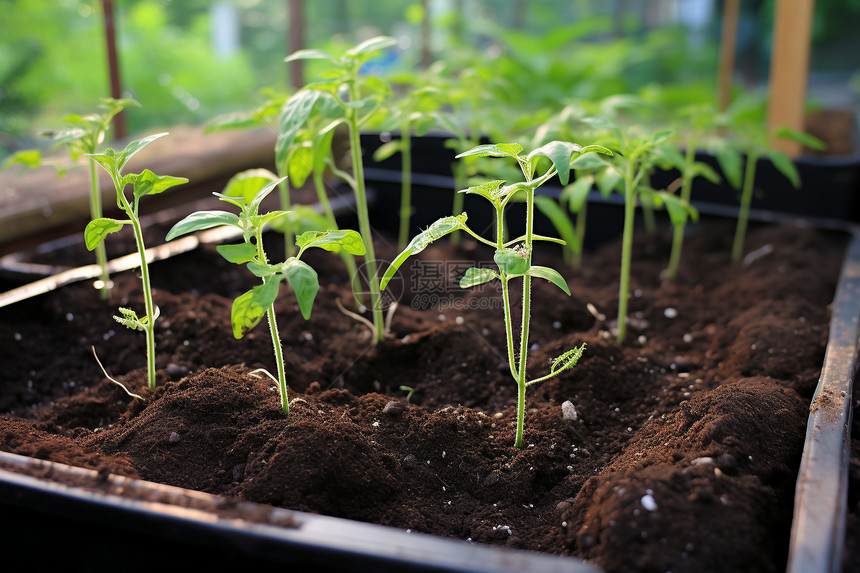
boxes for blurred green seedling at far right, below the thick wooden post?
[710,98,825,264]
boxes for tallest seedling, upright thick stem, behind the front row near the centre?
[282,36,397,343]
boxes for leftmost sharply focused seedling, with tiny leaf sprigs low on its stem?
[84,133,188,391]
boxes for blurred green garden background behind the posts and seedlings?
[0,0,860,160]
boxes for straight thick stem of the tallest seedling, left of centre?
[347,82,385,344]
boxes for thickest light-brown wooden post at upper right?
[767,0,815,157]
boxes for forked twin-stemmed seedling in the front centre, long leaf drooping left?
[382,141,611,448]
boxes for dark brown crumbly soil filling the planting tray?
[0,222,858,573]
